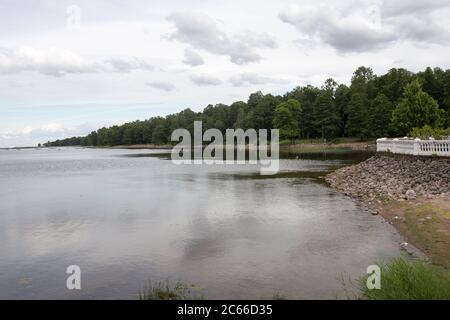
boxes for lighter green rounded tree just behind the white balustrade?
[392,80,444,135]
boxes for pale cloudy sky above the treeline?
[0,0,450,147]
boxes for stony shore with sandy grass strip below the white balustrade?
[325,154,450,268]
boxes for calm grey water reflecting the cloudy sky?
[0,148,401,299]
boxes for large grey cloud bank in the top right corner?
[279,0,450,53]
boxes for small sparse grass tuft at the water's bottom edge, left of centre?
[139,280,203,300]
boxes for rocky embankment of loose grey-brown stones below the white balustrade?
[325,154,450,204]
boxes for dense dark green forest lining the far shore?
[44,67,450,146]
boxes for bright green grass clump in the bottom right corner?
[360,258,450,300]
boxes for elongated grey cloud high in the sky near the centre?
[167,13,276,65]
